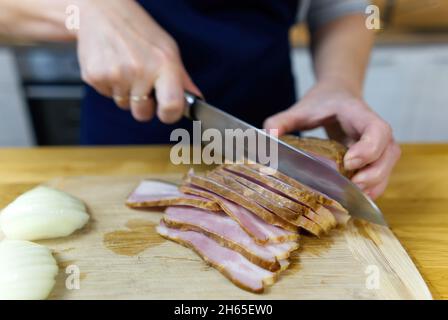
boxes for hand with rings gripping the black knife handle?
[77,0,201,123]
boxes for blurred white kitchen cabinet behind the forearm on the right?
[292,44,448,142]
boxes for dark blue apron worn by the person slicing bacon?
[81,0,298,144]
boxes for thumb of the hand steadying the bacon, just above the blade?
[263,103,319,136]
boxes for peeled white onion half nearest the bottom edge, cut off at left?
[0,240,59,300]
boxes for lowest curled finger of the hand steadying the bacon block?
[352,143,401,190]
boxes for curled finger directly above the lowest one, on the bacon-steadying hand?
[344,119,392,170]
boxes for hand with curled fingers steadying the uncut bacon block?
[264,82,401,198]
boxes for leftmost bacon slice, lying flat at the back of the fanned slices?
[126,180,221,211]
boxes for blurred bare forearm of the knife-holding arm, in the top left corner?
[0,0,83,41]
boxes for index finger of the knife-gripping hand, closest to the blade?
[154,69,185,124]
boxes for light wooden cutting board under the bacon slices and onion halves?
[0,175,432,299]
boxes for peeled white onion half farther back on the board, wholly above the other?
[0,186,89,240]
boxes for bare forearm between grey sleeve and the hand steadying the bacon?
[312,14,374,96]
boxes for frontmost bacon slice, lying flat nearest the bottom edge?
[157,222,277,293]
